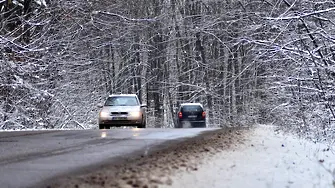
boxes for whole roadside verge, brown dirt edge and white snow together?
[44,126,335,188]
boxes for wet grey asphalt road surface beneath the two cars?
[0,128,217,188]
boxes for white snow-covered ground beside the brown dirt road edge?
[163,126,335,188]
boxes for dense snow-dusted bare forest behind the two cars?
[0,0,335,138]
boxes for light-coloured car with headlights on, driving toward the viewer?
[99,94,147,129]
